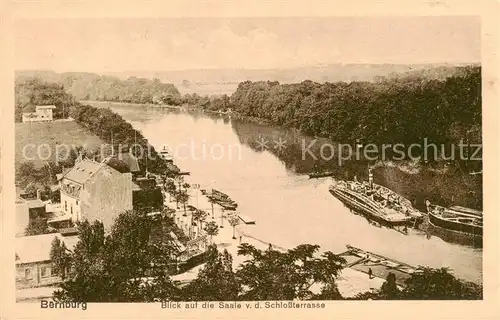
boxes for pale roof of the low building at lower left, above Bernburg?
[15,233,76,264]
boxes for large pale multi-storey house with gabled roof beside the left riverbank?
[59,159,132,229]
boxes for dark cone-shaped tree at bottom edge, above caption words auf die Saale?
[184,245,241,301]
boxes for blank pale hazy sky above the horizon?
[15,16,481,72]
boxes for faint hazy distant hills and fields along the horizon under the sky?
[16,64,478,97]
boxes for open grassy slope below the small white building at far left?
[15,121,104,166]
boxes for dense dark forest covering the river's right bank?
[223,67,481,149]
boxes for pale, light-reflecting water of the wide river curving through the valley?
[95,104,483,282]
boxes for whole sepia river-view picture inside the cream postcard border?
[2,1,494,318]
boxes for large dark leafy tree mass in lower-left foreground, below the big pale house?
[50,211,176,302]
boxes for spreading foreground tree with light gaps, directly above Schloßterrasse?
[236,243,345,300]
